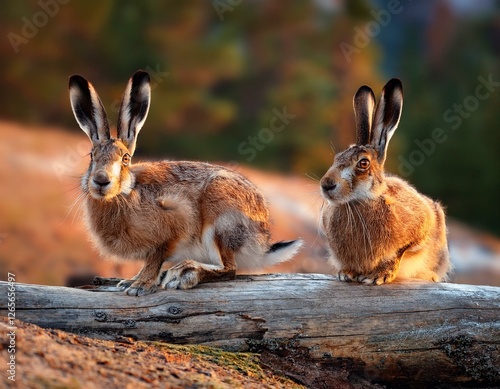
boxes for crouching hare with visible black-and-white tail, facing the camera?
[69,70,302,296]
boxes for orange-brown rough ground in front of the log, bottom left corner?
[0,318,303,389]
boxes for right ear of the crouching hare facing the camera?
[117,70,151,155]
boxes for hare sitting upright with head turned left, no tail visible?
[320,79,450,285]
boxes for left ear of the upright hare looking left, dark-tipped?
[353,85,375,146]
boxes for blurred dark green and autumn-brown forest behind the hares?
[0,0,500,284]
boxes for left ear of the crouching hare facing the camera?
[69,75,110,145]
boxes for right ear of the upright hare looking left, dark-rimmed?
[371,78,403,164]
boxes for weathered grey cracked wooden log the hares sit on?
[0,274,500,387]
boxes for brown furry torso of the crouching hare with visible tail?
[85,161,270,265]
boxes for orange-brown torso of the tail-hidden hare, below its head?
[322,176,437,273]
